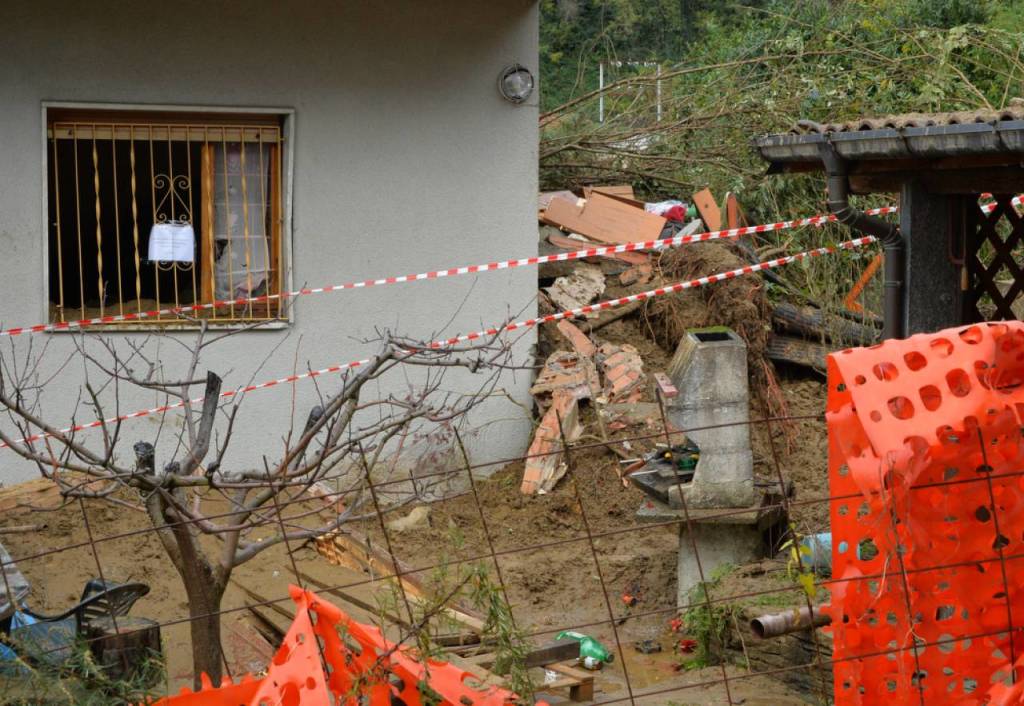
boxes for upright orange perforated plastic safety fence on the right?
[825,322,1024,706]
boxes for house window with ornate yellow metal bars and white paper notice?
[47,109,284,326]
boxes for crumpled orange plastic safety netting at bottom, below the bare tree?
[157,586,547,706]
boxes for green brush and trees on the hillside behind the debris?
[540,0,1024,319]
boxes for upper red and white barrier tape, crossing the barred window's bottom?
[0,206,897,336]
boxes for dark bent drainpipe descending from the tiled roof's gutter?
[819,139,906,339]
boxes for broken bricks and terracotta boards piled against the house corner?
[532,185,760,495]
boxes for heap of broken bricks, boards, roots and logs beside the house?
[521,185,880,494]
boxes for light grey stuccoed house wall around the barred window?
[0,0,538,484]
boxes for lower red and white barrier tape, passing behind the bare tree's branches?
[0,236,874,449]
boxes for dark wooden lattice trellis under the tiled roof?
[964,195,1024,322]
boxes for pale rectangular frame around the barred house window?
[39,100,295,333]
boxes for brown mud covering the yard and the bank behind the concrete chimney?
[0,240,828,706]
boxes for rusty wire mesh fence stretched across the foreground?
[0,368,1024,704]
